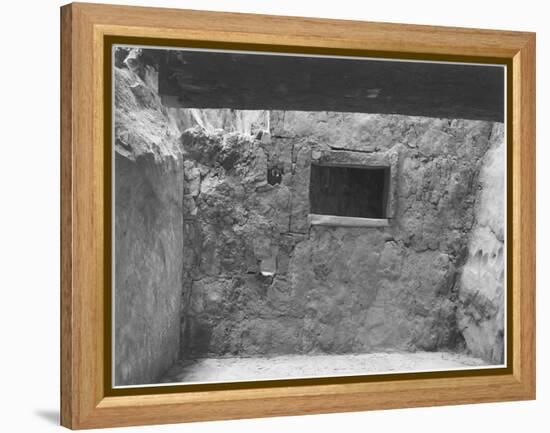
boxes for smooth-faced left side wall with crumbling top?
[113,58,184,385]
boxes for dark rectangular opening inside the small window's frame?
[309,164,390,218]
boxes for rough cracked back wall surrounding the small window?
[182,111,504,357]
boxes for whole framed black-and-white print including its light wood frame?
[61,4,535,429]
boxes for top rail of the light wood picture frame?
[72,2,530,59]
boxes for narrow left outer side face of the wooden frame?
[60,5,74,428]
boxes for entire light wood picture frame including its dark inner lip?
[60,3,536,429]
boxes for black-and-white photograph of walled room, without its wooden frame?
[111,45,507,387]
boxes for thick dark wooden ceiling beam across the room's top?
[152,50,505,122]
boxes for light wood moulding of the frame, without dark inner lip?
[61,4,535,428]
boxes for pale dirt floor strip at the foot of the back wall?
[161,352,492,383]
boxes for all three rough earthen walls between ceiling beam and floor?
[114,50,504,376]
